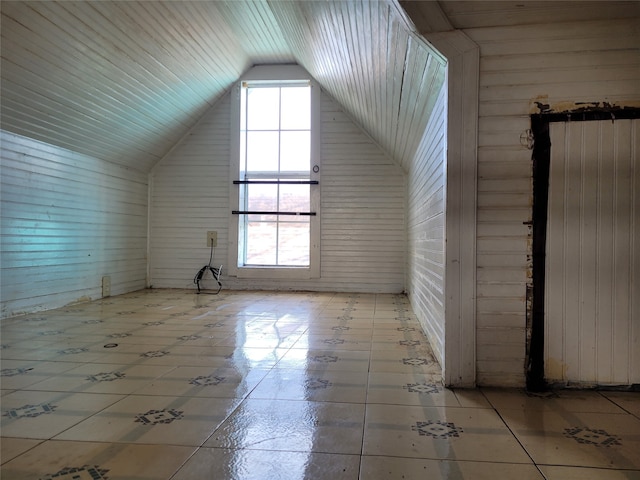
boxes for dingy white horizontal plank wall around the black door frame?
[465,19,640,386]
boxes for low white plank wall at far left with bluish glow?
[0,131,148,317]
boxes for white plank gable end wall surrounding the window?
[150,92,405,293]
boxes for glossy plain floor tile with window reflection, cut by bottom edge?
[172,448,360,480]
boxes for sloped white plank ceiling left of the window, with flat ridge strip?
[1,1,295,171]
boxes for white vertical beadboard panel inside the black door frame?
[544,120,640,386]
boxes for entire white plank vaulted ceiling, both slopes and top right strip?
[0,0,637,171]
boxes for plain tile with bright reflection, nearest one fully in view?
[205,399,364,454]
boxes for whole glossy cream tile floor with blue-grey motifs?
[0,290,640,480]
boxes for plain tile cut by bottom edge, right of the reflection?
[360,455,544,480]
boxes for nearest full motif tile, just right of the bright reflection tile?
[363,405,531,463]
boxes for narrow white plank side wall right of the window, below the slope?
[407,82,447,365]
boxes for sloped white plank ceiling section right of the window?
[269,0,446,172]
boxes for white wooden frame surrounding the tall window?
[228,65,321,279]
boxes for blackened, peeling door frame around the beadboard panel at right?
[526,105,640,392]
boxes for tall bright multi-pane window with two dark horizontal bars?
[230,67,319,278]
